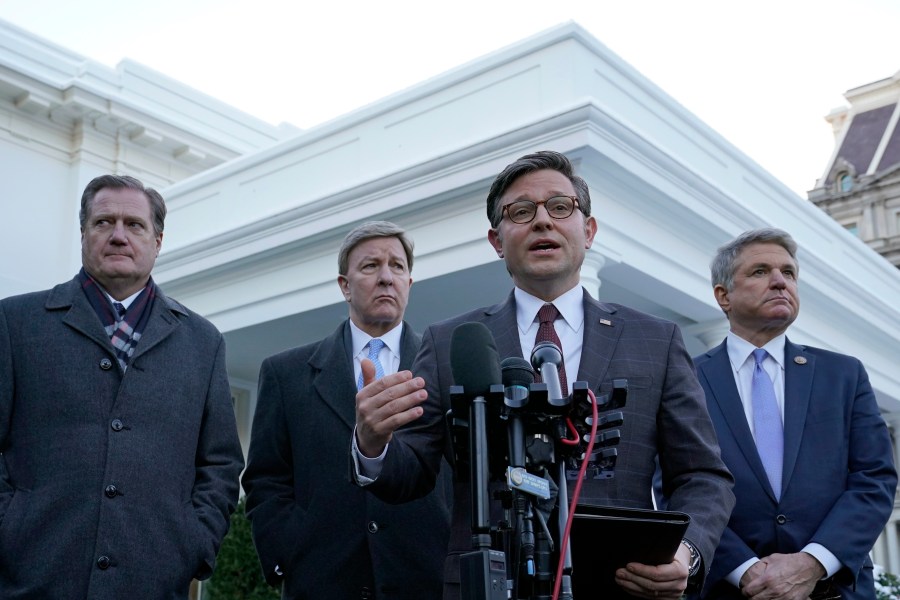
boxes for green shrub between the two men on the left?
[202,498,281,600]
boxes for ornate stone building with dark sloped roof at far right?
[809,71,900,267]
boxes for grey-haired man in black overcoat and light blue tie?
[243,221,450,600]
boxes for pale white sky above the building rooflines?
[0,0,900,198]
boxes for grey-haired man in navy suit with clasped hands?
[695,229,897,600]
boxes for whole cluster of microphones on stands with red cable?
[447,323,628,600]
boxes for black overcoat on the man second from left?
[243,321,450,600]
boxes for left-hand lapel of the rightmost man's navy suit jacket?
[697,342,775,501]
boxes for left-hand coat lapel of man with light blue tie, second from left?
[309,321,356,430]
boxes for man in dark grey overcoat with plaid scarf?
[0,175,243,600]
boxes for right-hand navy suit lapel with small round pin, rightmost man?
[782,340,816,489]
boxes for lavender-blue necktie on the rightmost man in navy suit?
[751,348,784,500]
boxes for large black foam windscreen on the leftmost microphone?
[450,323,502,396]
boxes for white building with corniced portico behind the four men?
[0,17,900,573]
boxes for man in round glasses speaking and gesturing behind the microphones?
[352,151,734,600]
